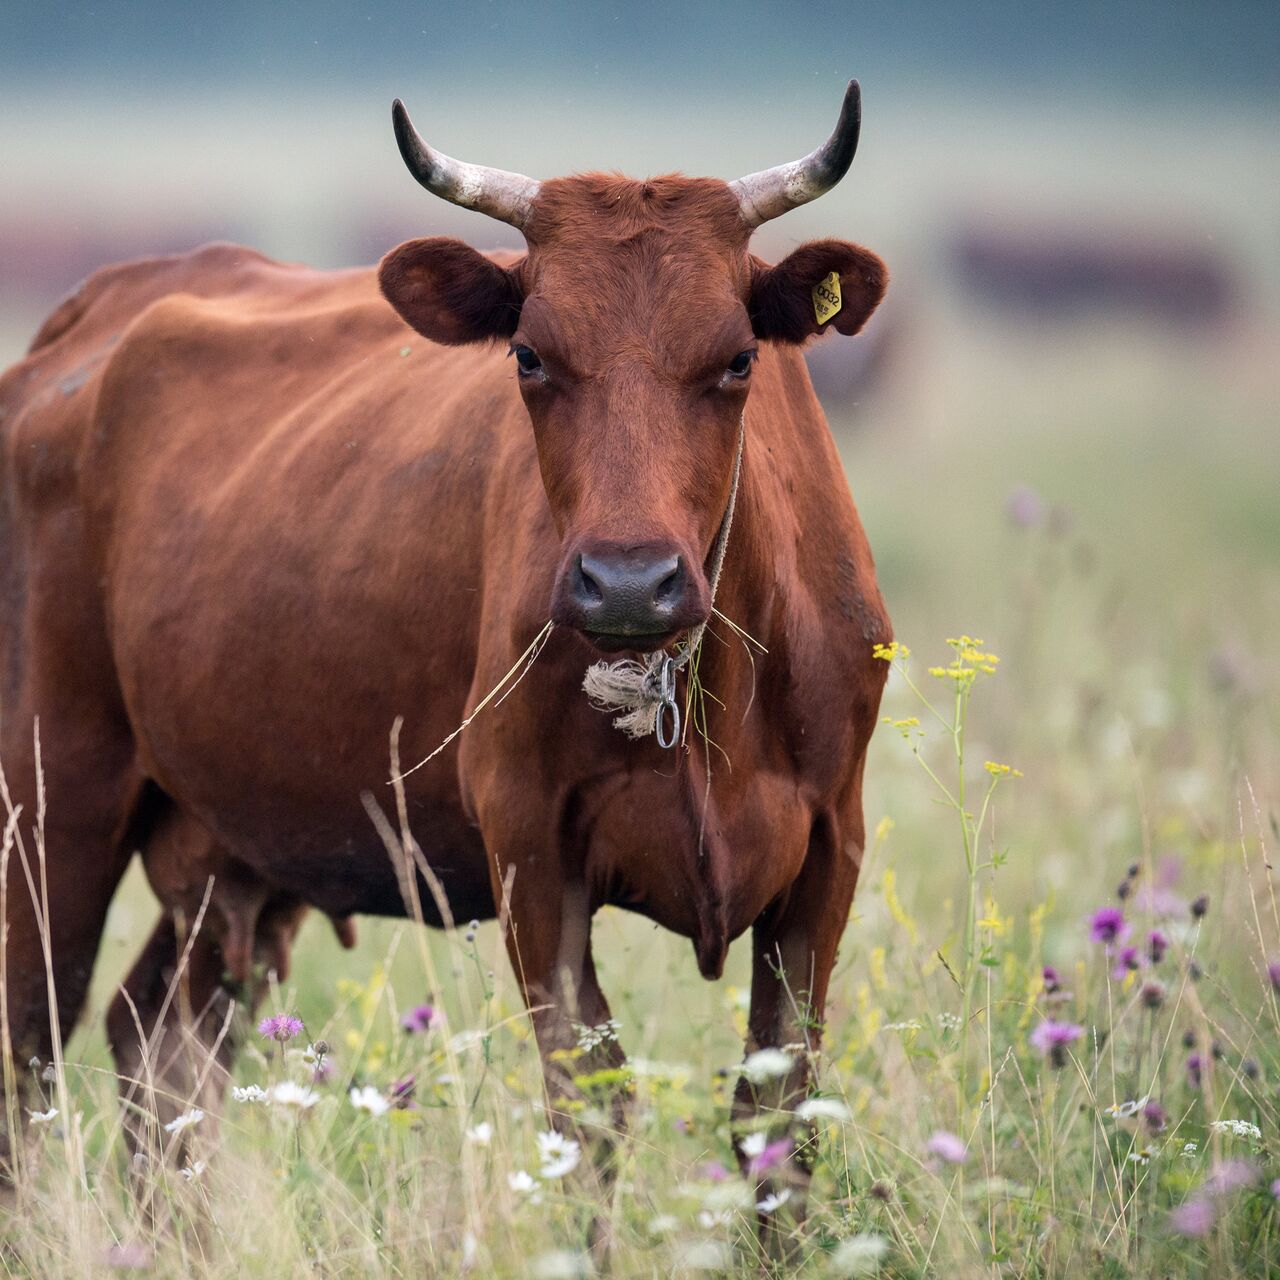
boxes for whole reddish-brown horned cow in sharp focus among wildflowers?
[0,84,890,1244]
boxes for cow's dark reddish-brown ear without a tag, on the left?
[378,236,524,346]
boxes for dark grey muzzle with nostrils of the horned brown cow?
[552,545,709,653]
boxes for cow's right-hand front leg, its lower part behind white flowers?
[733,820,861,1256]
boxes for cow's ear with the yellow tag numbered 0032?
[748,241,888,342]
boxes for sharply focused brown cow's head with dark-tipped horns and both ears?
[380,82,886,652]
